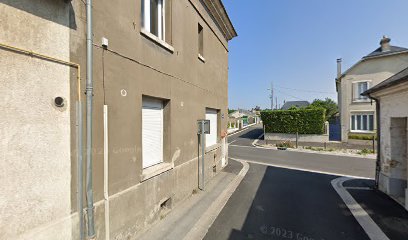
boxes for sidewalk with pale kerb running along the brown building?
[135,159,244,240]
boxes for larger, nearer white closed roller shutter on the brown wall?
[142,98,163,168]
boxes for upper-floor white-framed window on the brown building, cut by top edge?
[142,0,168,41]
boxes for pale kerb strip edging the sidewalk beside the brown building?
[183,160,249,240]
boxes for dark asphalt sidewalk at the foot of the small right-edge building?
[343,179,408,240]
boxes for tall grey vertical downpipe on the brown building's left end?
[86,0,96,239]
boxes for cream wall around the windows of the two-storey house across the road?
[340,53,408,142]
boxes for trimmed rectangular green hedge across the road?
[261,108,325,134]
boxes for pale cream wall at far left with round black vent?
[0,0,73,239]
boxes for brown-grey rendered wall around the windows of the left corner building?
[71,0,228,239]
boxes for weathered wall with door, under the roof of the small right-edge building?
[379,83,408,209]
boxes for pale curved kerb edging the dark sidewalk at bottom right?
[331,177,389,240]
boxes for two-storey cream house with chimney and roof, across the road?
[336,37,408,142]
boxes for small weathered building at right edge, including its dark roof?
[363,68,408,210]
